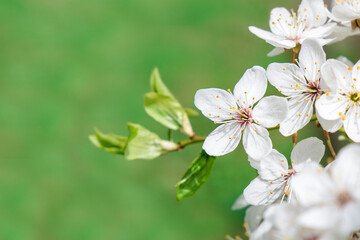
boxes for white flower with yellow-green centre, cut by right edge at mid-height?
[316,59,360,142]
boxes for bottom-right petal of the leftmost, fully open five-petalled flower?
[243,123,272,159]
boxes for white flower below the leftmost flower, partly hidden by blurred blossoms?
[244,138,325,205]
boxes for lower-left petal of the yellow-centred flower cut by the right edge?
[315,93,347,120]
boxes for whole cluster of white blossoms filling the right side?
[195,0,360,240]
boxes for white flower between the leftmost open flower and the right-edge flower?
[266,39,340,136]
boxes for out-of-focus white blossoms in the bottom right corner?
[245,144,360,240]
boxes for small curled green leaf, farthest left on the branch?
[89,128,127,155]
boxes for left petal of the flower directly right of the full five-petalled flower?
[266,63,306,96]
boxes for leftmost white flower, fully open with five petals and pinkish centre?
[195,66,287,158]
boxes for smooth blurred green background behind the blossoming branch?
[0,0,359,240]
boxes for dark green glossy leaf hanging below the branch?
[176,150,215,201]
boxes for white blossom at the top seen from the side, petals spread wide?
[249,0,336,56]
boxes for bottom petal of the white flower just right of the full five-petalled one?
[279,94,313,136]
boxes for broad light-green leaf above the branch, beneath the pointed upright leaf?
[145,92,187,130]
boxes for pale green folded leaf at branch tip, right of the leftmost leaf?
[125,123,163,160]
